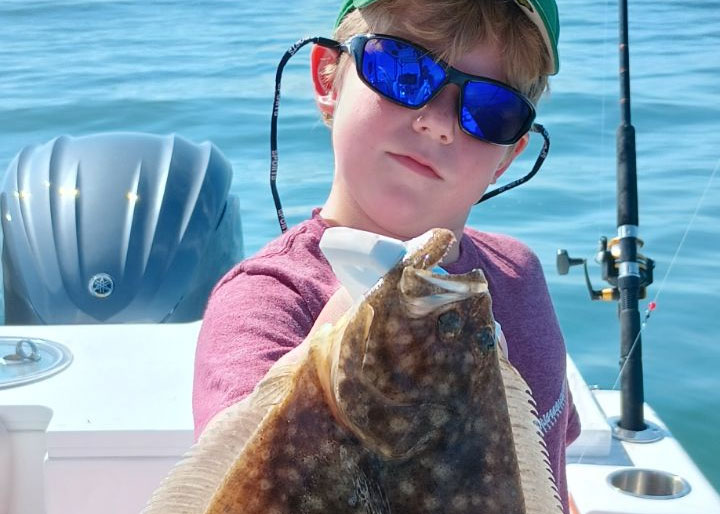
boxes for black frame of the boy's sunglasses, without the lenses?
[338,33,536,146]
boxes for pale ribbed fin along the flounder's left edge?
[142,344,304,514]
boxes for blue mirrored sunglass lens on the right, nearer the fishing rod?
[461,82,532,144]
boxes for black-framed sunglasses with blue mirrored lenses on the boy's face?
[339,34,535,145]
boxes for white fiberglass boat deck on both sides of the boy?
[0,322,720,514]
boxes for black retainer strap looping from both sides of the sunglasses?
[270,37,550,233]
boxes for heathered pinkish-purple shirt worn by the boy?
[193,209,580,512]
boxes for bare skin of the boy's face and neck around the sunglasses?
[316,34,528,239]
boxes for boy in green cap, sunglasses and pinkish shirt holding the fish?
[193,0,579,512]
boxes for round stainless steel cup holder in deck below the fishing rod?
[608,468,690,500]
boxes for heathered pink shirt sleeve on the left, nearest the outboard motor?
[193,265,314,439]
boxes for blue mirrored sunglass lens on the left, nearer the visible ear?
[362,38,445,107]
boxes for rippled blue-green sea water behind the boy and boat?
[0,0,720,488]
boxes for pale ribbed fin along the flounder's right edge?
[498,352,563,514]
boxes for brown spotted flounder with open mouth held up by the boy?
[144,229,562,514]
